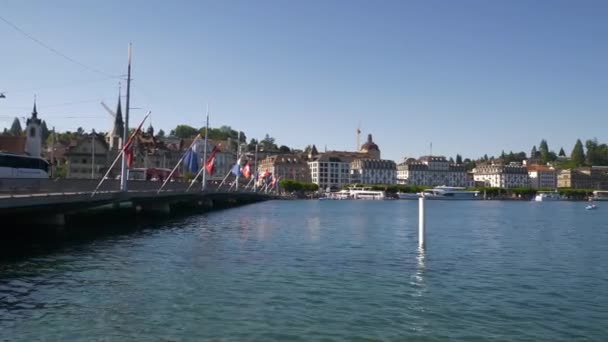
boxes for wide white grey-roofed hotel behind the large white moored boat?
[397,156,473,187]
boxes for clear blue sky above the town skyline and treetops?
[0,0,608,161]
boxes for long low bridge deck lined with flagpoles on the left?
[0,178,274,226]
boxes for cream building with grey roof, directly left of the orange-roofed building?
[473,163,530,189]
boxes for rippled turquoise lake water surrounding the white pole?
[0,201,608,341]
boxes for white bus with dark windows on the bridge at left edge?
[0,152,49,178]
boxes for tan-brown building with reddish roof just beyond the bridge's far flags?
[252,154,311,183]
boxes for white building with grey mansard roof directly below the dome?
[349,159,397,184]
